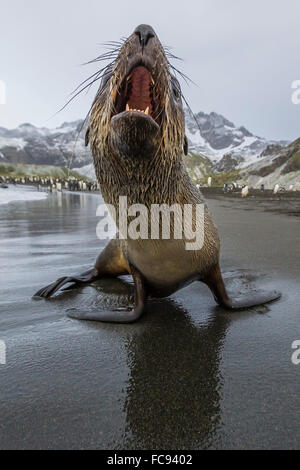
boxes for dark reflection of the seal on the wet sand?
[125,300,230,450]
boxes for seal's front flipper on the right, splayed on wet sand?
[202,265,281,310]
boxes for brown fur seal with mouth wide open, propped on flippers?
[35,25,280,323]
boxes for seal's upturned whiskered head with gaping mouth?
[89,25,185,159]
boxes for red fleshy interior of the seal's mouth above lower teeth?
[127,66,152,115]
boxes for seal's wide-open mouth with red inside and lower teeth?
[115,65,159,123]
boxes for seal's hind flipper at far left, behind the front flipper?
[33,268,99,299]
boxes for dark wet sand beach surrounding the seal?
[0,193,300,450]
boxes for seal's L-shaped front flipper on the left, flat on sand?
[67,266,147,323]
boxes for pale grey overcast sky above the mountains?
[0,0,300,139]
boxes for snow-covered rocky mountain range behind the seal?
[0,111,288,182]
